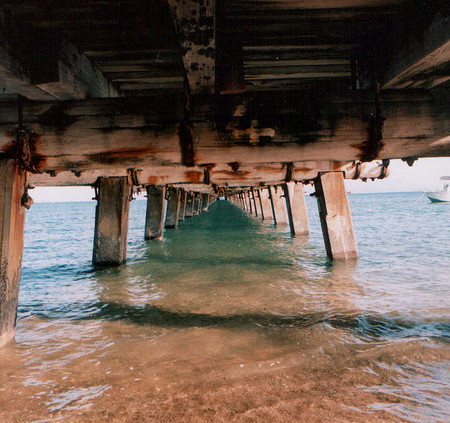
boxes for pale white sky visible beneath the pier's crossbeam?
[29,158,450,202]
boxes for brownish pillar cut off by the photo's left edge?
[0,159,26,347]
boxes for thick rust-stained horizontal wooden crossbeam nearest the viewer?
[0,90,450,176]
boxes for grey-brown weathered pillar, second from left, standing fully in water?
[92,176,131,266]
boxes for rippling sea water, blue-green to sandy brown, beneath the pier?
[0,193,450,423]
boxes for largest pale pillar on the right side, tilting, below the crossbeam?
[315,172,358,259]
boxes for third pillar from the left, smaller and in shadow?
[145,185,166,239]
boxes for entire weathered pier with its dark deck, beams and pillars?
[0,0,450,346]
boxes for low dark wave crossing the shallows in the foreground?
[18,302,450,342]
